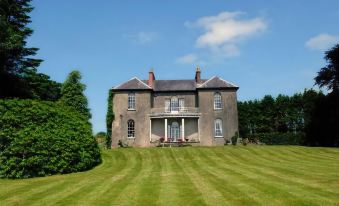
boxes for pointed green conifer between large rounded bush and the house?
[59,70,91,120]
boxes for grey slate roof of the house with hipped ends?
[113,76,238,92]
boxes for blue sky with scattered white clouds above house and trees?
[28,0,339,133]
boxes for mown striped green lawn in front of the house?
[0,146,339,206]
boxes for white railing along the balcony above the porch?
[151,107,199,115]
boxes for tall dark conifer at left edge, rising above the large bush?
[0,0,42,98]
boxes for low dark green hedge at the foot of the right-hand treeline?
[250,132,304,145]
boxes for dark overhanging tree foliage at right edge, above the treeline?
[314,44,339,92]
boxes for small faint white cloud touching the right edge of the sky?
[305,33,339,51]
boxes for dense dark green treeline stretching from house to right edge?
[238,89,339,146]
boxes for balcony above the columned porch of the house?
[150,107,200,118]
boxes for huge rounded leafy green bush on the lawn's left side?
[0,100,101,178]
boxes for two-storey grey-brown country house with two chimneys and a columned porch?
[112,68,239,148]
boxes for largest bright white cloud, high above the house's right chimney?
[185,12,267,57]
